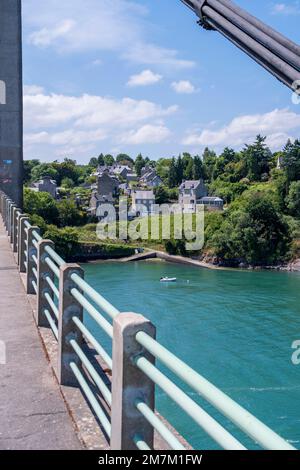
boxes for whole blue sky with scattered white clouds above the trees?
[22,0,300,162]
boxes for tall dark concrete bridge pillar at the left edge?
[0,0,23,207]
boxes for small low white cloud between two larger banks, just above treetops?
[121,124,171,145]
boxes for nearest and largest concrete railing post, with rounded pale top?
[111,313,156,450]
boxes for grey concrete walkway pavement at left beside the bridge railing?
[0,220,82,450]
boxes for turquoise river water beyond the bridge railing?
[85,262,300,449]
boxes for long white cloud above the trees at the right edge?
[183,109,300,150]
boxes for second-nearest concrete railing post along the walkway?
[58,264,84,387]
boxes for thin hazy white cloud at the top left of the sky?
[23,0,195,68]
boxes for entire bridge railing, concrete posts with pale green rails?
[0,192,294,450]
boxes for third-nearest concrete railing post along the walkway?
[35,240,54,328]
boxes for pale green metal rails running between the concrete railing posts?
[0,192,294,450]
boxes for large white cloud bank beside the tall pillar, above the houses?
[24,87,178,158]
